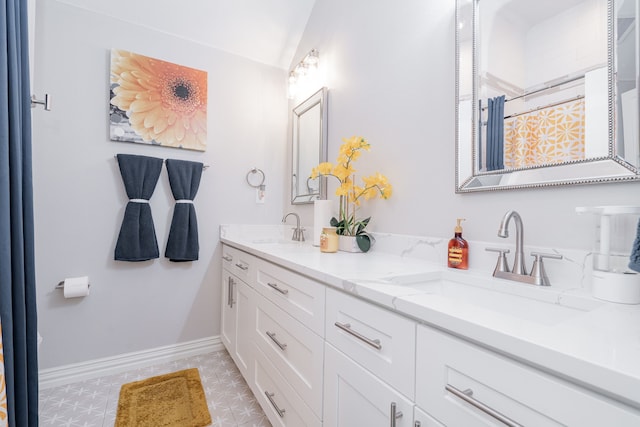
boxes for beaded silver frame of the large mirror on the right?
[455,0,640,193]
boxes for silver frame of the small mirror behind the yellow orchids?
[291,87,328,205]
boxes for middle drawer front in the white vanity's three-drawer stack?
[255,298,324,417]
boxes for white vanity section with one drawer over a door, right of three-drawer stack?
[323,289,416,427]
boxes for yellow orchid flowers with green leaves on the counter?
[311,136,393,252]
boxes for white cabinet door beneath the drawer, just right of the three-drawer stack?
[323,344,413,427]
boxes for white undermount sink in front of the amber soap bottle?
[376,270,604,325]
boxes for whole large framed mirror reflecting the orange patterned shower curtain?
[456,0,640,193]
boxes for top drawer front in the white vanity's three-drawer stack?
[256,260,325,336]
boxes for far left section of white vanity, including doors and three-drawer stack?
[222,245,325,427]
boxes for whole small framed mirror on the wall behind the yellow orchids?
[291,88,328,205]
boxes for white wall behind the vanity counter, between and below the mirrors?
[288,0,640,252]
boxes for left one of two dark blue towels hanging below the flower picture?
[115,154,162,261]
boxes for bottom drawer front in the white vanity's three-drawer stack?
[253,347,322,427]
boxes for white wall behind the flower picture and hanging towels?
[33,0,288,368]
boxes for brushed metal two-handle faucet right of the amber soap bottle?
[486,211,562,286]
